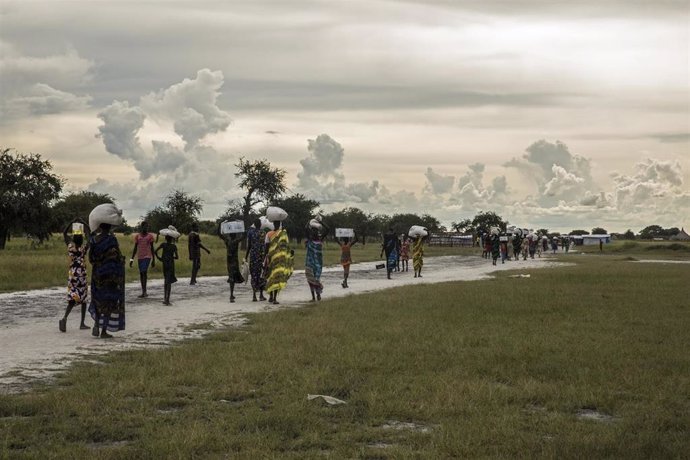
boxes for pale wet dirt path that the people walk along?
[0,256,555,393]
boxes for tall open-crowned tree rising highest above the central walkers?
[235,158,286,227]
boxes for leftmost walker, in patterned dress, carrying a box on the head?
[58,218,89,332]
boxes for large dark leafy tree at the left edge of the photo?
[0,149,63,249]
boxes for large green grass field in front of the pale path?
[0,253,690,459]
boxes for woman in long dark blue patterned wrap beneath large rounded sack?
[89,223,125,339]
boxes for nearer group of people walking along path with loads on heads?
[58,209,414,338]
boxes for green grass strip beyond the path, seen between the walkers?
[0,235,476,292]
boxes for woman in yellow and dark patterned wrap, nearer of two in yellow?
[266,221,295,305]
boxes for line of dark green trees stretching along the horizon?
[0,148,679,249]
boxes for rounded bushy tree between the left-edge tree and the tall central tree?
[144,190,203,233]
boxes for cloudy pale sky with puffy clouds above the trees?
[0,0,690,231]
